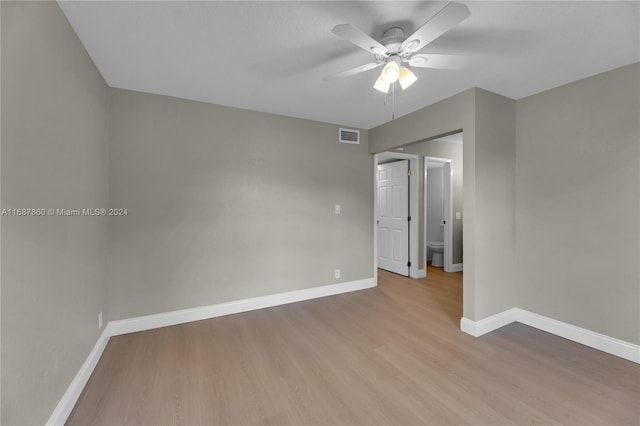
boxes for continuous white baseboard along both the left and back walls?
[46,278,376,426]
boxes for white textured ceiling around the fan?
[59,1,640,128]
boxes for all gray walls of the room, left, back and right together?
[0,2,640,424]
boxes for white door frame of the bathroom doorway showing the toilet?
[423,155,453,272]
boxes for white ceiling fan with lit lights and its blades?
[331,3,471,93]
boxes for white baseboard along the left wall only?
[46,324,111,426]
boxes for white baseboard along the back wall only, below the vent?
[110,278,376,336]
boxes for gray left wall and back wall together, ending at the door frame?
[1,2,373,424]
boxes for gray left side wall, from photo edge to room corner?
[0,1,109,425]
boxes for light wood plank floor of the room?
[68,268,640,426]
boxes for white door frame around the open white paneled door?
[373,151,424,283]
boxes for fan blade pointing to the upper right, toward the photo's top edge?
[402,3,471,52]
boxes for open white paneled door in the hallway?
[378,160,409,276]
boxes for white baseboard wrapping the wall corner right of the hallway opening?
[460,308,640,364]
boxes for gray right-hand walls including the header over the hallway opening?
[369,64,640,343]
